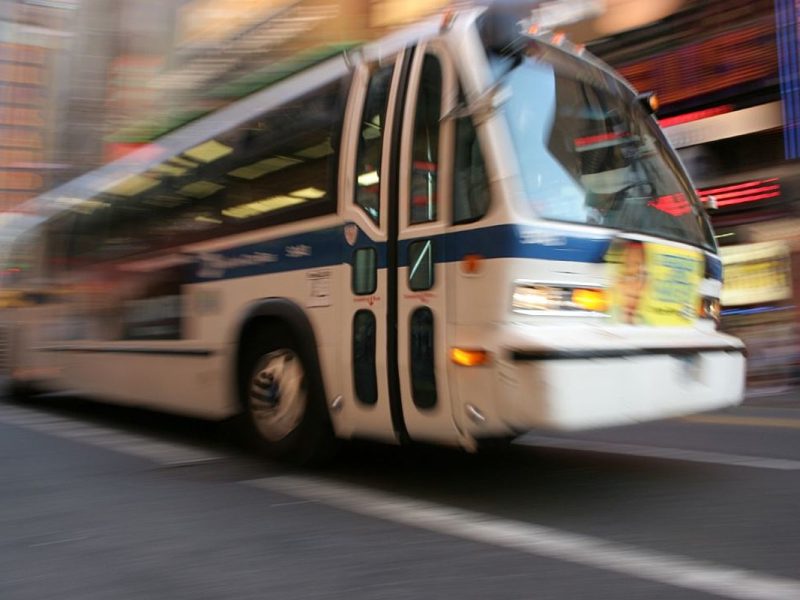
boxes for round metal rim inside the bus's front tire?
[248,349,308,442]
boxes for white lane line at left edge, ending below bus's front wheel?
[0,405,223,466]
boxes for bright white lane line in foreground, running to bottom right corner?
[252,475,800,600]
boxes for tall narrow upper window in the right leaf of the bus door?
[409,54,442,225]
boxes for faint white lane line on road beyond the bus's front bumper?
[514,435,800,471]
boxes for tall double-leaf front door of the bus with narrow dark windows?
[340,43,458,443]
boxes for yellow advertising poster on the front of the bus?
[606,239,704,327]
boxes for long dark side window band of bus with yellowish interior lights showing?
[73,75,345,262]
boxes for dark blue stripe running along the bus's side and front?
[192,225,722,282]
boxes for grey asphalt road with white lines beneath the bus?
[0,396,800,600]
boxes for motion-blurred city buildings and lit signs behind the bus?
[0,0,800,398]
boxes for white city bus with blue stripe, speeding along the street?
[3,8,745,462]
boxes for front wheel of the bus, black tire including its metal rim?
[239,327,336,466]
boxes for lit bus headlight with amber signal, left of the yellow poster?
[511,283,608,315]
